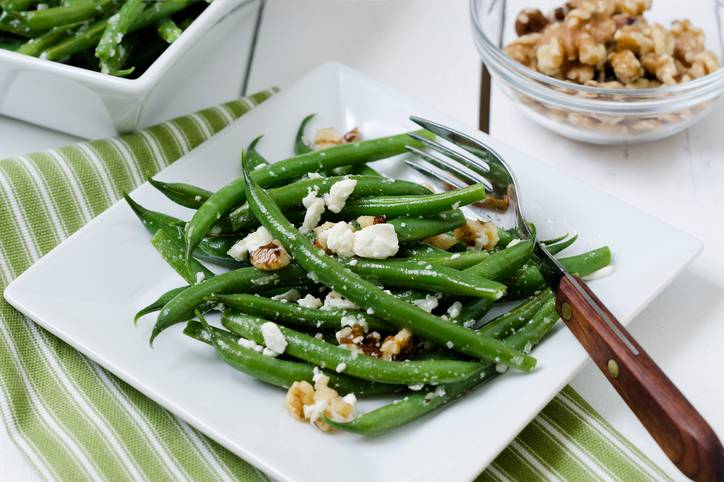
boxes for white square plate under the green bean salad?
[5,64,701,482]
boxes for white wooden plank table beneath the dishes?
[0,0,724,480]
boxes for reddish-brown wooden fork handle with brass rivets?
[556,275,724,481]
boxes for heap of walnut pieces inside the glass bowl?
[504,0,720,88]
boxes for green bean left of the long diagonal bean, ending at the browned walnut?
[209,294,388,331]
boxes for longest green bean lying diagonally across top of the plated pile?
[240,153,536,371]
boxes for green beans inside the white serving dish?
[0,0,208,78]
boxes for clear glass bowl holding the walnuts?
[470,0,724,144]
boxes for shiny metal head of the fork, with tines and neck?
[406,116,532,239]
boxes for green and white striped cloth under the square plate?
[0,90,666,481]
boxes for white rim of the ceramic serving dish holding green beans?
[0,0,262,94]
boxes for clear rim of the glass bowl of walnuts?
[469,0,724,100]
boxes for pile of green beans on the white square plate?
[125,116,611,435]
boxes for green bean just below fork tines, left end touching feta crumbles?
[340,184,485,218]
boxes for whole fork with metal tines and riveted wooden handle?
[406,116,724,481]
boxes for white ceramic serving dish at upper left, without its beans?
[0,0,261,139]
